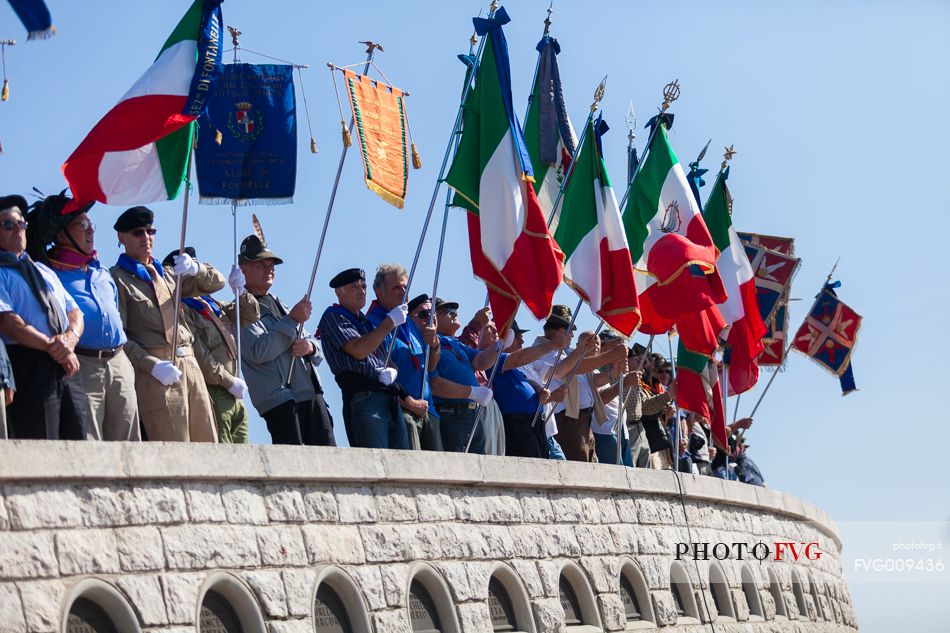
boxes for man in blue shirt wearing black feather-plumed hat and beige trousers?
[27,192,142,441]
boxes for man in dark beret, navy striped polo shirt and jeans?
[320,268,409,449]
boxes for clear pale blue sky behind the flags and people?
[0,0,950,631]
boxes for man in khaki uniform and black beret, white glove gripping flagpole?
[109,207,224,442]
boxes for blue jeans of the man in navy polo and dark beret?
[344,391,409,449]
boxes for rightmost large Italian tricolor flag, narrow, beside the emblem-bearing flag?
[703,167,766,394]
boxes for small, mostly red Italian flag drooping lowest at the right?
[676,340,729,449]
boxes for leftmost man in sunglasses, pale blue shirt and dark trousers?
[0,195,89,439]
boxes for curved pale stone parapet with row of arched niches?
[0,441,857,633]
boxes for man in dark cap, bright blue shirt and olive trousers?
[387,294,443,451]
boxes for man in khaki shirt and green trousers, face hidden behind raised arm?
[162,246,261,444]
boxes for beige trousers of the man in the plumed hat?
[78,350,142,442]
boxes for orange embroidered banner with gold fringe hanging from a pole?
[343,70,409,209]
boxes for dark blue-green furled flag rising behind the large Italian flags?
[524,35,577,231]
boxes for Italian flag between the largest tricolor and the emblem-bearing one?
[554,119,640,336]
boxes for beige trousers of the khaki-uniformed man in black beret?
[135,350,218,442]
